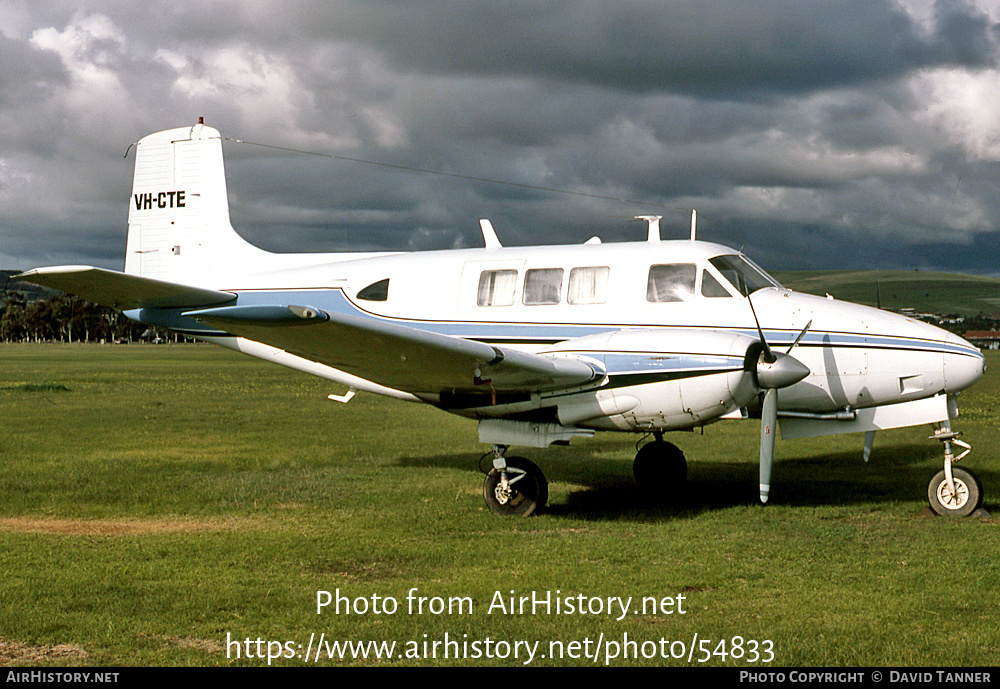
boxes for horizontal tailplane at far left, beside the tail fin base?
[14,266,236,311]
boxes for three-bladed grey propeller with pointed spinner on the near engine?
[747,294,812,503]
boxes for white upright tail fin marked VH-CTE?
[125,123,271,287]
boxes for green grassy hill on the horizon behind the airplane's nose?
[773,270,1000,317]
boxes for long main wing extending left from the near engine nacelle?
[183,305,604,396]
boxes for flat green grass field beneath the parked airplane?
[0,345,1000,668]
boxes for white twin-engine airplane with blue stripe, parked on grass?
[18,123,985,516]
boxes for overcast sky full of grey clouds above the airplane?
[0,0,1000,275]
